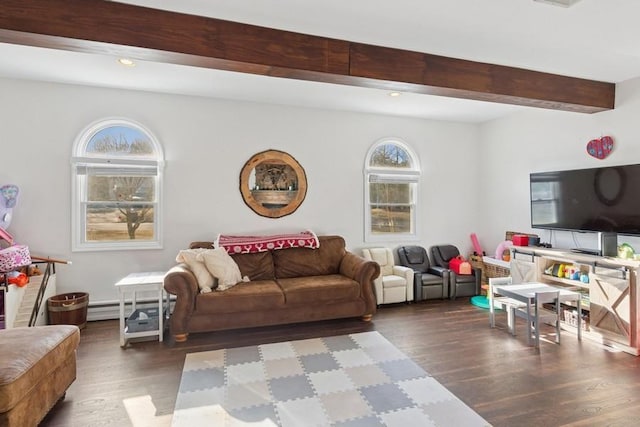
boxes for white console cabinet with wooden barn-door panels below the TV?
[511,247,640,356]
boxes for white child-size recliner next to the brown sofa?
[362,248,414,304]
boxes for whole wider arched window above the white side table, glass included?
[71,119,164,251]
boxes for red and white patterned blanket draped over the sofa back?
[215,230,320,254]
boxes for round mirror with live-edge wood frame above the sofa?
[240,150,307,218]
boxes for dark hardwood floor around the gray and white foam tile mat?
[42,298,640,427]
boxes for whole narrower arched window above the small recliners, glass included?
[364,138,420,242]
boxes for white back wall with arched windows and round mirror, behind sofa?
[0,79,480,305]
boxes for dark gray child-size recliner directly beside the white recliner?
[398,246,449,301]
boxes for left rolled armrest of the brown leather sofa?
[164,264,199,340]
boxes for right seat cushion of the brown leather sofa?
[278,274,360,305]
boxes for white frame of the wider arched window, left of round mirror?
[71,118,164,252]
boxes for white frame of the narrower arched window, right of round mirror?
[364,137,421,242]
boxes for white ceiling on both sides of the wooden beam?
[0,0,640,123]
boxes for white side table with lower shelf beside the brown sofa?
[115,271,165,347]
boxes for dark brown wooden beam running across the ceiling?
[0,0,615,113]
